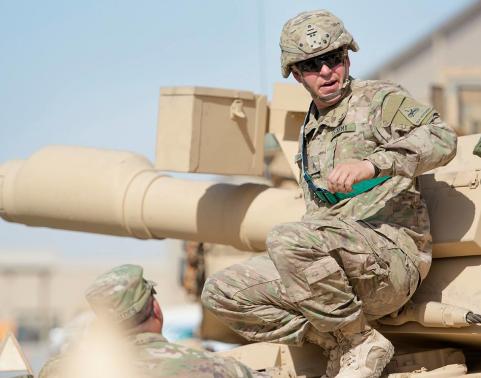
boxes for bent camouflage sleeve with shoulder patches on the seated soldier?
[366,94,457,178]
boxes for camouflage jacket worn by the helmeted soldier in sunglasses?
[296,79,457,279]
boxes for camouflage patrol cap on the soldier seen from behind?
[85,264,155,323]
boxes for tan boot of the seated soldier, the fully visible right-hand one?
[336,328,394,378]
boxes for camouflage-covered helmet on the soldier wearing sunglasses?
[280,10,359,77]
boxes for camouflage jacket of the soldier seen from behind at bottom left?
[39,333,262,378]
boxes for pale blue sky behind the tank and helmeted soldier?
[0,0,473,257]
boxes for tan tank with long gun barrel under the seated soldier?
[0,84,481,377]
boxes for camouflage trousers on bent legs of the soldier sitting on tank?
[202,219,419,349]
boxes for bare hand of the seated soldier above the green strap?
[327,159,376,193]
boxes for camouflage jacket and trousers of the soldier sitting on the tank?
[203,79,456,346]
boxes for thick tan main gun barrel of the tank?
[0,146,304,251]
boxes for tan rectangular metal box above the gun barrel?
[155,87,267,175]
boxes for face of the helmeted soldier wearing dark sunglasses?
[292,57,350,109]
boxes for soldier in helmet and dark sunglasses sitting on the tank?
[202,10,456,378]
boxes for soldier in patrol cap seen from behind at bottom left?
[39,265,267,378]
